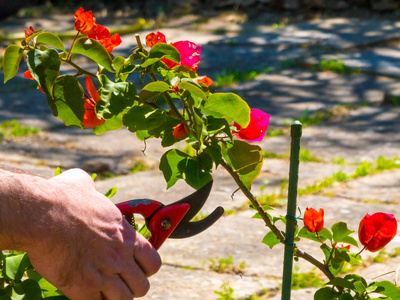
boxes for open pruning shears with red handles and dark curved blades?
[117,181,224,249]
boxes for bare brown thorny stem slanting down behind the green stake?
[217,159,335,280]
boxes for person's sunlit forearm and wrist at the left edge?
[0,167,57,251]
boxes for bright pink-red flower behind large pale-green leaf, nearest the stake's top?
[233,109,270,142]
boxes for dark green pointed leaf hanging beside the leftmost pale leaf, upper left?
[27,49,61,97]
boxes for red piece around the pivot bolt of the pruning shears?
[149,203,190,250]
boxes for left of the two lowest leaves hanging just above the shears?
[159,149,189,189]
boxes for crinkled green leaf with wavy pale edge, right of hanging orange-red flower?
[96,74,136,119]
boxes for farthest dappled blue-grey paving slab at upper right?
[208,18,400,50]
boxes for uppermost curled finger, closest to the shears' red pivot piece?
[133,232,161,277]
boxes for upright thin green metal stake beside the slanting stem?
[281,121,302,300]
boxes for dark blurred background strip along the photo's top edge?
[0,0,400,18]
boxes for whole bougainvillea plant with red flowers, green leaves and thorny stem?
[0,8,400,300]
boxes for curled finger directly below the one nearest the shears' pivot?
[120,260,150,297]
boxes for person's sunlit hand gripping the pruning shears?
[28,169,161,300]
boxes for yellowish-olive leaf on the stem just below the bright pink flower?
[223,140,263,189]
